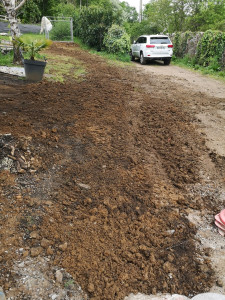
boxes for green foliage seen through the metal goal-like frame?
[50,21,71,41]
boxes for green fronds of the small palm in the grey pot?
[14,36,52,60]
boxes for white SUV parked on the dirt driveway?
[130,35,173,65]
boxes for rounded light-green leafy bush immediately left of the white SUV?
[103,24,130,53]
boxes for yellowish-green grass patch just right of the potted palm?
[42,52,86,82]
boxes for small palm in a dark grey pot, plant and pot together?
[15,36,52,82]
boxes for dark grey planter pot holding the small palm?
[24,59,46,82]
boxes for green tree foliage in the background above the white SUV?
[144,0,225,33]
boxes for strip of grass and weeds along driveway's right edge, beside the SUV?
[172,56,225,81]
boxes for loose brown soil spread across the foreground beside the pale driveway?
[0,44,220,300]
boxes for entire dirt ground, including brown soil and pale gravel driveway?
[0,44,225,300]
